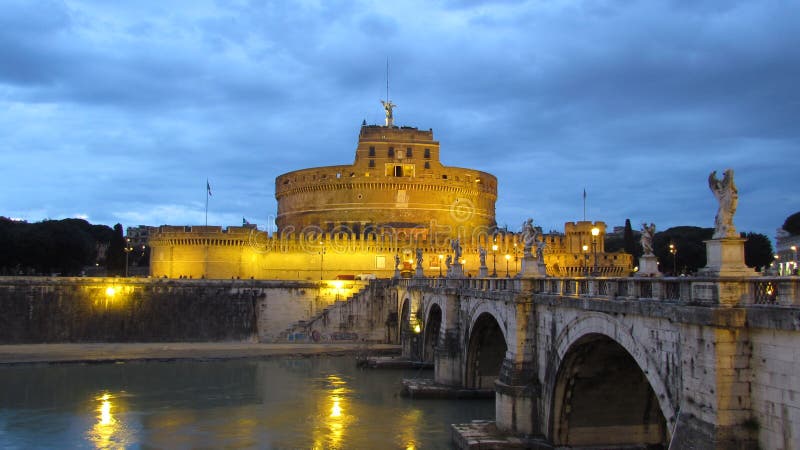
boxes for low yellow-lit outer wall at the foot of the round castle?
[150,222,633,280]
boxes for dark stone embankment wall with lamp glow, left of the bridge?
[0,277,364,344]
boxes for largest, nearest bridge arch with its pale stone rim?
[544,313,675,448]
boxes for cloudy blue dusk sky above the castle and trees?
[0,0,800,238]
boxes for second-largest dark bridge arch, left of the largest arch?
[464,311,508,389]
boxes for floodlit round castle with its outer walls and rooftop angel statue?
[149,106,632,280]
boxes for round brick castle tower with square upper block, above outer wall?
[275,125,497,236]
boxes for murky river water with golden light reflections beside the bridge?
[0,356,494,450]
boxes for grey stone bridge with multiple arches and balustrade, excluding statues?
[392,277,800,449]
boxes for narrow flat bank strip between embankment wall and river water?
[0,342,400,365]
